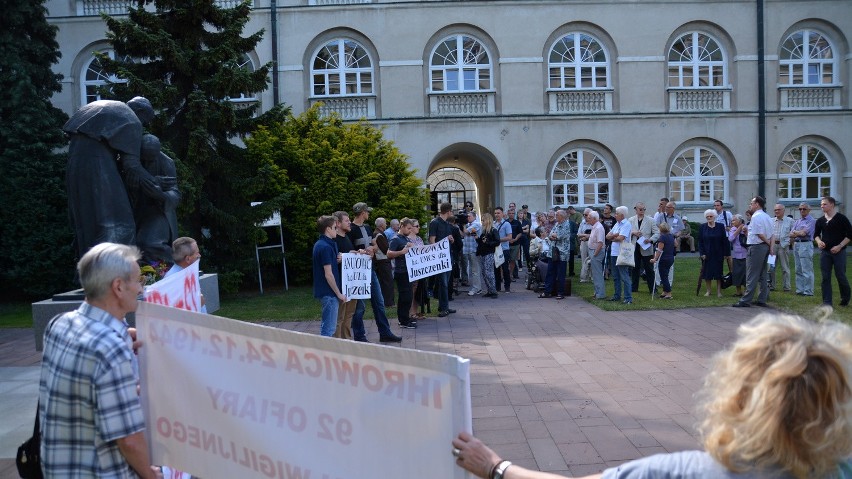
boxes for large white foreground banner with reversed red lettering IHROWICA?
[136,303,472,479]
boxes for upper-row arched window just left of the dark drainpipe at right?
[668,32,728,88]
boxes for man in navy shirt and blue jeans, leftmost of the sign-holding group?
[313,216,346,336]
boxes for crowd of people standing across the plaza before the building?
[314,196,852,342]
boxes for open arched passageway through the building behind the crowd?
[426,143,503,212]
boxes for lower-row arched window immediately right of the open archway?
[551,148,610,207]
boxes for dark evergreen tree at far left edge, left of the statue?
[0,0,74,296]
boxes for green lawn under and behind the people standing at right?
[573,256,852,324]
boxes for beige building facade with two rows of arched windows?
[47,0,852,218]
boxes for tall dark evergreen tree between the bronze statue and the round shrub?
[101,0,281,289]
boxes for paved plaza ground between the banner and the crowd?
[0,283,760,478]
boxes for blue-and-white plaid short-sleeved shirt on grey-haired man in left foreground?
[39,302,145,478]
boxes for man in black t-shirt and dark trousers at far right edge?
[814,196,852,306]
